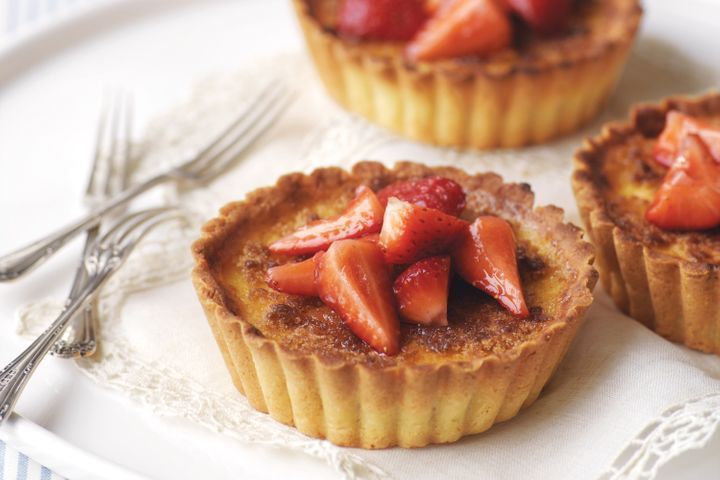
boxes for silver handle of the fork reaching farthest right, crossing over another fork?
[0,174,169,282]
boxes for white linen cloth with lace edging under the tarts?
[19,45,720,480]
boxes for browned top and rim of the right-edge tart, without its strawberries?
[573,93,720,265]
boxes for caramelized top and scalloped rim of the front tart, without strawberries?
[193,162,597,366]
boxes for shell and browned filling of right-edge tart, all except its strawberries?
[572,93,720,354]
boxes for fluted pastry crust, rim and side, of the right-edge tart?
[572,92,720,354]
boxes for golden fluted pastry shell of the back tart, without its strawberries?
[293,0,642,149]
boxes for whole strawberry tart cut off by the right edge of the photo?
[573,93,720,354]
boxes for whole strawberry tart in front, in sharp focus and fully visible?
[193,162,597,448]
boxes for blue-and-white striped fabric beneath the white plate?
[0,0,87,480]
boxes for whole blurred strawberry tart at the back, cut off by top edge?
[293,0,642,148]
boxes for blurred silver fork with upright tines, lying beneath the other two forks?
[50,91,132,358]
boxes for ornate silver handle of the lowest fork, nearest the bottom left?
[0,269,112,425]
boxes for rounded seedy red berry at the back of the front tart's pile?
[377,177,465,216]
